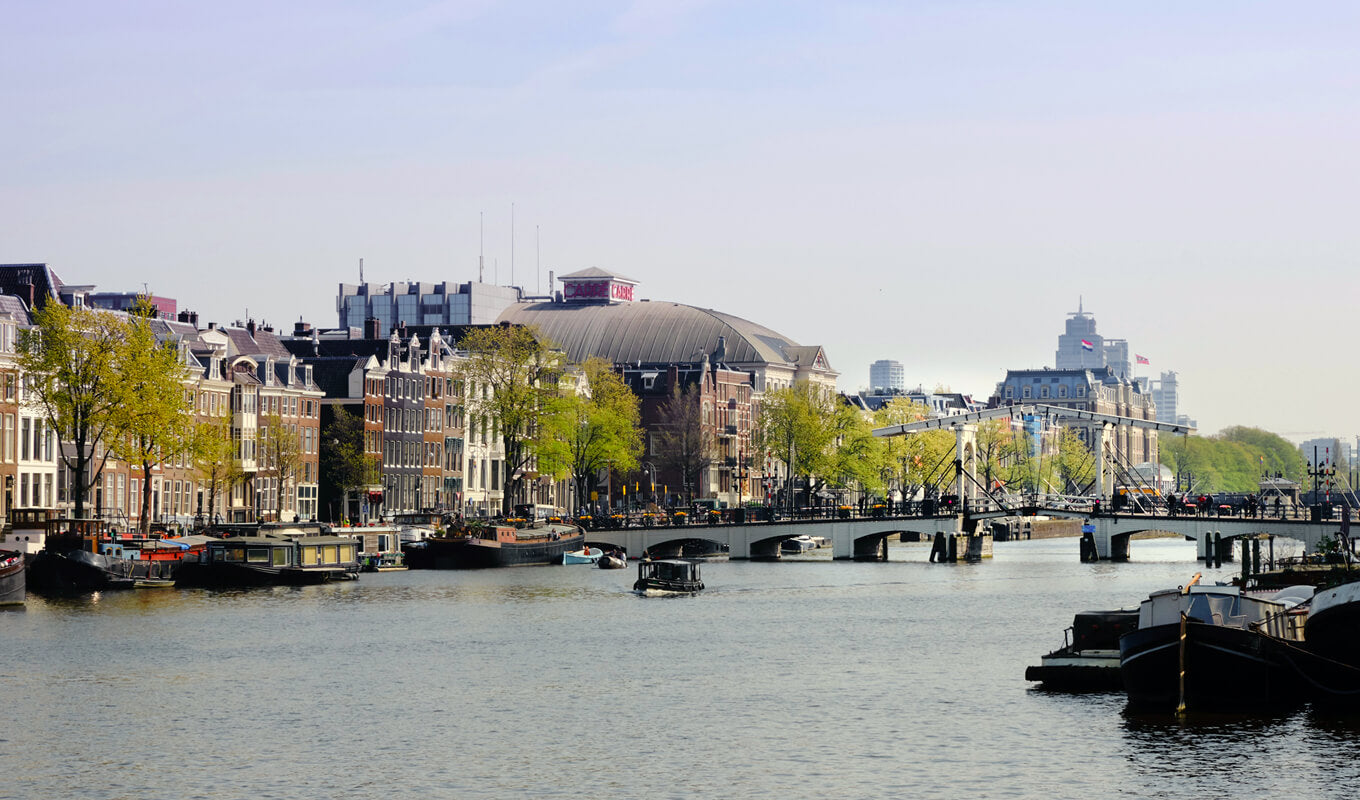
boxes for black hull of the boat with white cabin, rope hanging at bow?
[1119,622,1304,712]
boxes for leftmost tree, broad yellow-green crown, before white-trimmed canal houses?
[18,301,132,518]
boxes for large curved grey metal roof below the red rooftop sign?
[496,301,816,365]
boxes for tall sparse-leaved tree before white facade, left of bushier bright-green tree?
[458,325,563,517]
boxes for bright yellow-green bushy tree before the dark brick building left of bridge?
[539,358,642,507]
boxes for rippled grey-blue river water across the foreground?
[0,539,1360,800]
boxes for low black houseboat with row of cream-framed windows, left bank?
[175,535,359,588]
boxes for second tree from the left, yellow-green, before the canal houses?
[109,303,193,533]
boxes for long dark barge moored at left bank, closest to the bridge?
[403,522,586,570]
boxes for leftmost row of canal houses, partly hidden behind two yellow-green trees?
[0,276,322,529]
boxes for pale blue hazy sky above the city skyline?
[0,0,1360,441]
